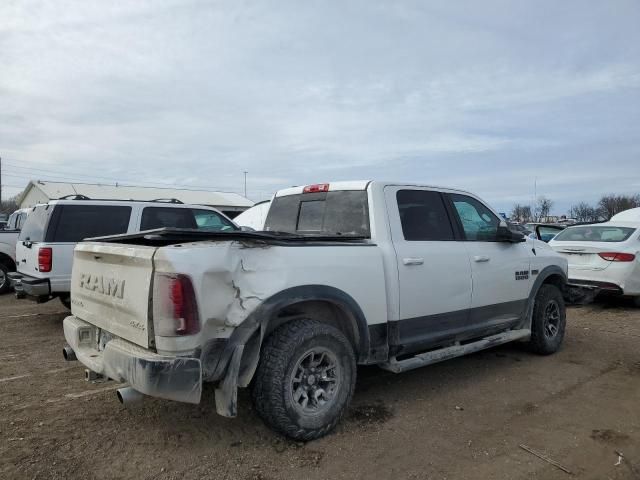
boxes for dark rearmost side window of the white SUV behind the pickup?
[46,205,131,242]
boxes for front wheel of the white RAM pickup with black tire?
[528,285,567,355]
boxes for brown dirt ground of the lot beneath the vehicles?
[0,295,640,480]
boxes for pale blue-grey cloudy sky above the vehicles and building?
[0,0,640,213]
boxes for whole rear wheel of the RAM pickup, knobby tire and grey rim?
[252,319,356,441]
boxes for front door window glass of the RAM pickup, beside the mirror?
[450,194,500,242]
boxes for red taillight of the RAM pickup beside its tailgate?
[153,274,200,337]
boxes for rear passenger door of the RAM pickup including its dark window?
[385,186,472,353]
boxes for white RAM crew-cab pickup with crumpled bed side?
[63,181,567,440]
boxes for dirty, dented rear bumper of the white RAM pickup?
[63,316,202,403]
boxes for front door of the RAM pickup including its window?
[447,193,532,330]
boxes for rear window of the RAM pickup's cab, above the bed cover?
[264,190,370,238]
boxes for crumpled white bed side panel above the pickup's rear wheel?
[154,241,387,351]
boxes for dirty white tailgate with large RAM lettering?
[71,243,156,347]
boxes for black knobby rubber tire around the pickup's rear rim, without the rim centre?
[252,319,356,441]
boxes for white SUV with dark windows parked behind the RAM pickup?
[9,197,240,308]
